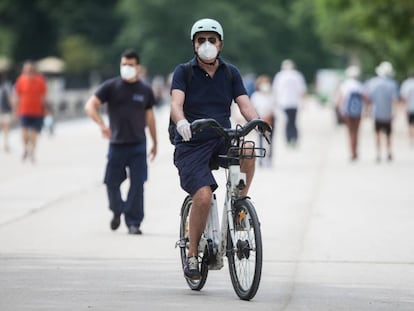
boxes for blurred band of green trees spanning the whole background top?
[0,0,414,81]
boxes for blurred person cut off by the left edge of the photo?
[0,72,13,152]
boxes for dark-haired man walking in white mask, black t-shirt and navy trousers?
[85,49,157,234]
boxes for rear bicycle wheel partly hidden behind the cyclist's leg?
[180,196,208,291]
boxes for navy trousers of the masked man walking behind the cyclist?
[104,144,147,227]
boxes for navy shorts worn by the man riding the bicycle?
[174,138,227,195]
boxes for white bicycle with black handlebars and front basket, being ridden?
[176,119,272,300]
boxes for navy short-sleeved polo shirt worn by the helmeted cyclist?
[171,57,247,142]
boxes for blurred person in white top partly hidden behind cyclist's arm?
[250,75,275,167]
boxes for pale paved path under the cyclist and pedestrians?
[0,98,414,311]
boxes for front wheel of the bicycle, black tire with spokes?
[227,199,263,300]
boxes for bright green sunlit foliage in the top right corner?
[315,0,414,78]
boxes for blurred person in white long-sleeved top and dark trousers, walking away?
[272,59,307,147]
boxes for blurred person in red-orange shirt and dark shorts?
[15,61,47,162]
